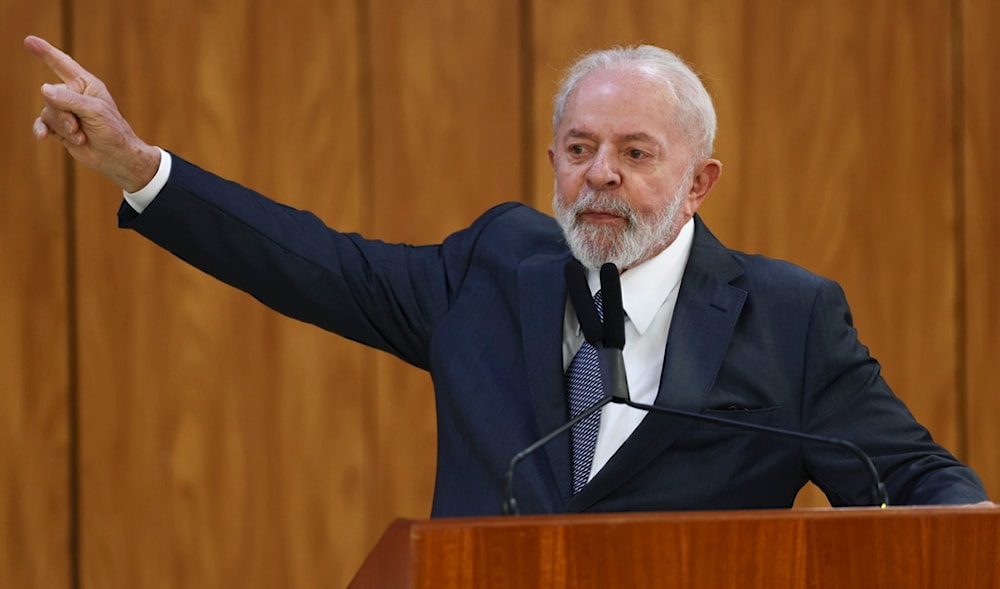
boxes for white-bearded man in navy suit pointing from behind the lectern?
[25,37,986,516]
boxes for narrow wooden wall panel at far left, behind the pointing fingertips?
[0,0,73,589]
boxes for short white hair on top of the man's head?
[552,45,717,158]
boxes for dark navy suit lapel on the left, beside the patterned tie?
[518,254,572,501]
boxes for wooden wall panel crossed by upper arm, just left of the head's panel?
[368,0,522,531]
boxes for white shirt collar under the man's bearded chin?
[587,218,694,335]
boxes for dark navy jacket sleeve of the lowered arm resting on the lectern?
[802,281,987,505]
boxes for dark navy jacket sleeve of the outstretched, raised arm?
[119,156,502,369]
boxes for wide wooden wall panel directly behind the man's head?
[533,0,958,504]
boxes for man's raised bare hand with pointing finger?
[24,36,160,192]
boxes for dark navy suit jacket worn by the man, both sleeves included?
[120,156,986,516]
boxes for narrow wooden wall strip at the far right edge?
[962,0,1000,501]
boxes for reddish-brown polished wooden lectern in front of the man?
[350,507,1000,589]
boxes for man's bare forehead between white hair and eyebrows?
[556,70,677,142]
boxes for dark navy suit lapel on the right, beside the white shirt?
[567,217,747,511]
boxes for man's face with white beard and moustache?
[549,71,717,270]
